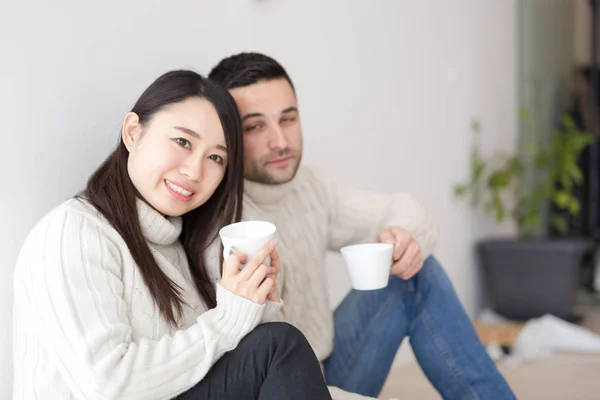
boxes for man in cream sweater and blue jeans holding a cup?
[209,53,514,400]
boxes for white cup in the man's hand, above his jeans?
[340,243,394,290]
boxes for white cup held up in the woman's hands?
[219,221,277,265]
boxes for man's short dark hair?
[208,53,294,89]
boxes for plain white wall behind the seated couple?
[0,0,516,398]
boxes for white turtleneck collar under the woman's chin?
[136,198,183,245]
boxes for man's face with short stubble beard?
[229,78,302,185]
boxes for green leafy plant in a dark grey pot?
[454,112,593,320]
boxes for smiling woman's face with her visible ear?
[123,97,227,217]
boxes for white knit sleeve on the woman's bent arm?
[16,206,265,400]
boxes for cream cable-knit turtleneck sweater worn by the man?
[244,167,438,398]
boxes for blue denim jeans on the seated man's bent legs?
[324,257,515,400]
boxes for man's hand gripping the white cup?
[377,226,423,280]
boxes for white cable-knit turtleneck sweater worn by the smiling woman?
[13,200,281,400]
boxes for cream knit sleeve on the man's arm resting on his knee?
[315,167,438,258]
